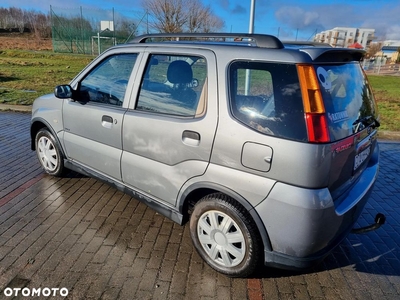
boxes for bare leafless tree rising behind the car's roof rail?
[142,0,224,33]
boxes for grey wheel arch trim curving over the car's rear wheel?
[178,182,272,251]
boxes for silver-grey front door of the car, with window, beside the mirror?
[63,53,138,180]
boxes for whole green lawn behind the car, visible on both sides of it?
[0,50,400,132]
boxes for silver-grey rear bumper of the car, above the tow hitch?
[256,144,379,269]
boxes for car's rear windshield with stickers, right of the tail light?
[315,63,378,141]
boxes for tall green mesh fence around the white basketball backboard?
[50,6,148,55]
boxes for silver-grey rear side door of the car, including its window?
[121,49,217,205]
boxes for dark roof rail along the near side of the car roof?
[131,33,284,49]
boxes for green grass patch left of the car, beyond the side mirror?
[0,50,93,105]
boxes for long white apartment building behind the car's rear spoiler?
[314,27,375,49]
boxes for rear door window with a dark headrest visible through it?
[136,54,207,118]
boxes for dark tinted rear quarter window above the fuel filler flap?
[229,61,307,141]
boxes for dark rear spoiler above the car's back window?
[299,47,366,63]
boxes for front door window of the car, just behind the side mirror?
[79,53,137,106]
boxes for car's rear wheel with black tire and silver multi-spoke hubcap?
[190,193,262,277]
